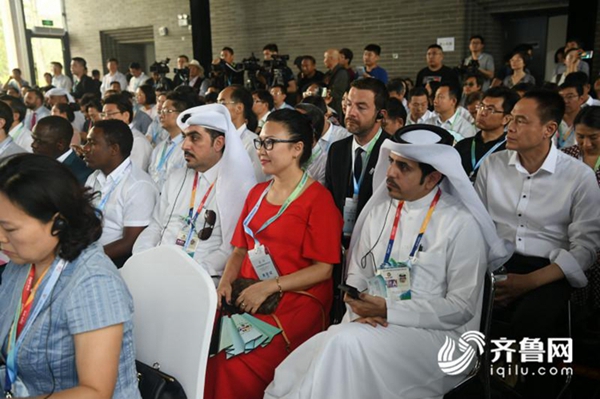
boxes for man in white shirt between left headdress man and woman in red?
[217,85,266,183]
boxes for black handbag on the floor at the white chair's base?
[135,360,187,399]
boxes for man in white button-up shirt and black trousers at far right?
[475,90,600,398]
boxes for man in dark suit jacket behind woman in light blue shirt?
[31,116,92,186]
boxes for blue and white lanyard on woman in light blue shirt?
[4,259,68,393]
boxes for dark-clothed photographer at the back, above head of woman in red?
[257,43,297,99]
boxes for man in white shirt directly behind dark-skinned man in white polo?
[100,94,152,172]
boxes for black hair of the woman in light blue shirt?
[0,154,102,261]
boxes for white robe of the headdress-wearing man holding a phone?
[265,189,487,399]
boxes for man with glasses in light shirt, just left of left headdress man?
[148,92,193,192]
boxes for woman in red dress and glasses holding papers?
[204,110,342,399]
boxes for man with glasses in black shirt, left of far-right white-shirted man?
[454,86,519,182]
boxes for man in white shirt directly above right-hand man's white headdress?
[425,82,477,142]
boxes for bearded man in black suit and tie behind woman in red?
[325,78,389,236]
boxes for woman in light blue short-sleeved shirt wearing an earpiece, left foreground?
[0,154,141,399]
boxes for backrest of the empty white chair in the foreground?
[121,245,217,398]
